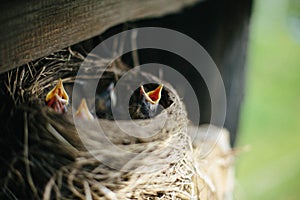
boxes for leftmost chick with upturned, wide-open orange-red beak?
[45,79,69,113]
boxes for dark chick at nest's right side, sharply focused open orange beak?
[130,84,163,119]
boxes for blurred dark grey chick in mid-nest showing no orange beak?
[95,82,117,118]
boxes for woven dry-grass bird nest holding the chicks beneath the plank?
[0,49,233,200]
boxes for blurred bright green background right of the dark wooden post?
[235,0,300,200]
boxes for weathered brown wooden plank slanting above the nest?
[0,0,197,73]
